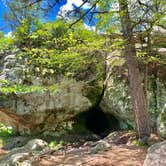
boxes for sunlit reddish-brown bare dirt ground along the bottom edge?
[33,145,147,166]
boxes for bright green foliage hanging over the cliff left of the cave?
[0,19,105,103]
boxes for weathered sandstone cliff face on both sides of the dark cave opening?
[0,52,166,138]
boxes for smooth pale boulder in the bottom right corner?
[144,141,166,166]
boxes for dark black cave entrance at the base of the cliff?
[73,107,120,137]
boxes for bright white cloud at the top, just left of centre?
[58,0,89,17]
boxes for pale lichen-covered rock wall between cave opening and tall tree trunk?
[100,50,134,129]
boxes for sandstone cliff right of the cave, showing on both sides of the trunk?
[100,51,166,138]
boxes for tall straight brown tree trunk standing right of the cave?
[119,0,150,139]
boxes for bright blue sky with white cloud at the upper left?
[0,0,95,34]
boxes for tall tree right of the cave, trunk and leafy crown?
[71,0,165,139]
